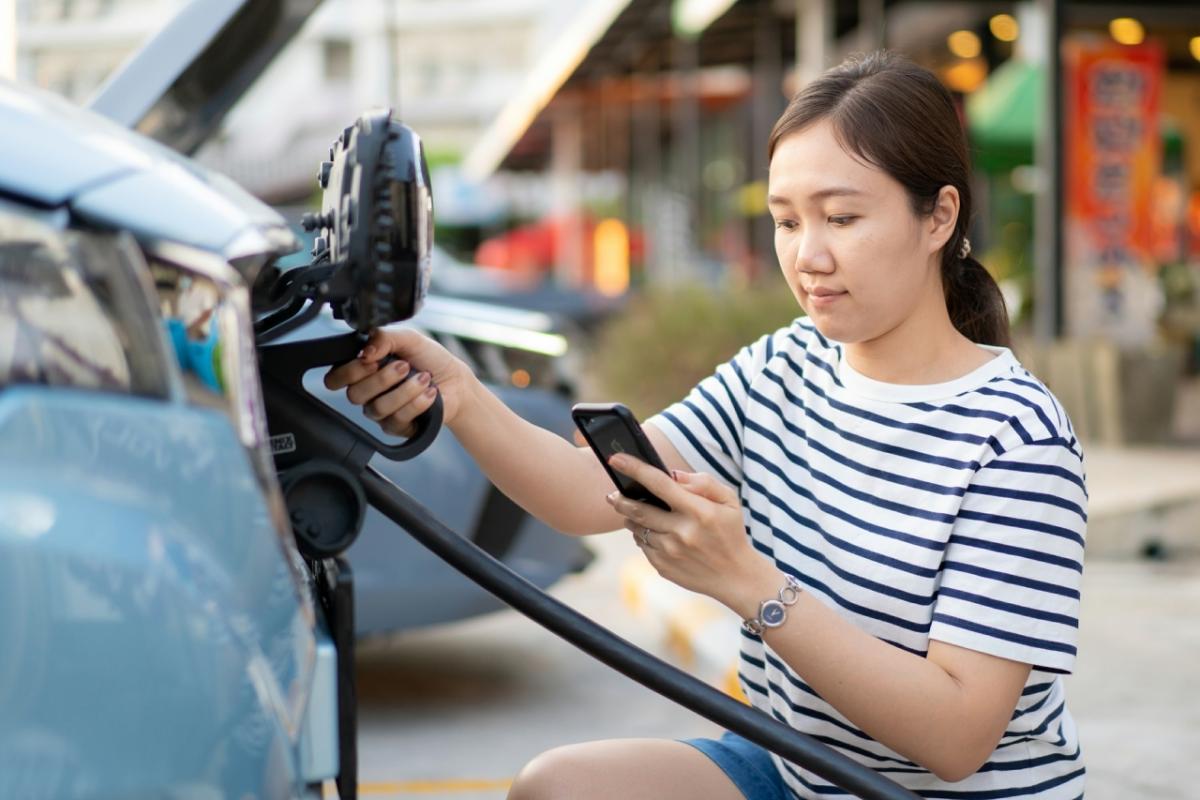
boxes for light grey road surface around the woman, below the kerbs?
[350,515,1200,800]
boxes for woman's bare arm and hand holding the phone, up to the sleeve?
[608,456,1031,781]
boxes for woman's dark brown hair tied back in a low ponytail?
[767,50,1009,347]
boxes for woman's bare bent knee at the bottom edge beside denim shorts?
[509,739,745,800]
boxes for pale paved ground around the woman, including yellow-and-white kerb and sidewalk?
[345,381,1200,800]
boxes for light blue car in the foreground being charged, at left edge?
[0,74,341,798]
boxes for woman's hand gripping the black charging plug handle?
[325,329,475,437]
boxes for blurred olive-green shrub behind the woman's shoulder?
[581,276,804,420]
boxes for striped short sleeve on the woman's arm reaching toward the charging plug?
[644,327,791,489]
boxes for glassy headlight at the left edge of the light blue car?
[0,201,173,398]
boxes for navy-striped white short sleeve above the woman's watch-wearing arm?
[929,439,1087,673]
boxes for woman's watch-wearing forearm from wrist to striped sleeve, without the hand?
[719,558,1031,782]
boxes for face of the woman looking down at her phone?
[767,120,956,344]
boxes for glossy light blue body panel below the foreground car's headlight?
[0,386,316,798]
